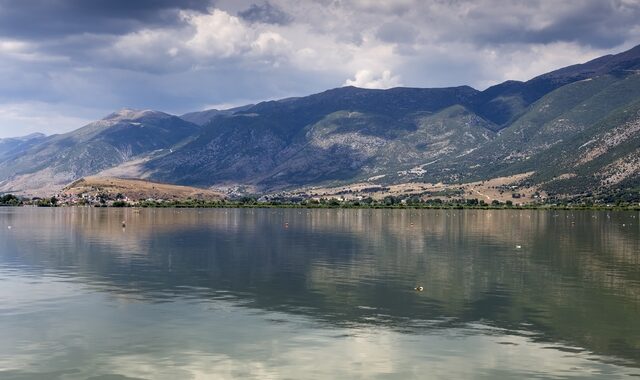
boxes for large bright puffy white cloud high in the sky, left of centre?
[101,9,290,72]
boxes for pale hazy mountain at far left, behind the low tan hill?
[0,109,200,192]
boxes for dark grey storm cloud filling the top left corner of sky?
[0,0,212,40]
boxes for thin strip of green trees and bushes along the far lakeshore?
[0,194,640,211]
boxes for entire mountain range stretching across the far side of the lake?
[0,46,640,199]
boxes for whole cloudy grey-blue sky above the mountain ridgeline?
[0,0,640,138]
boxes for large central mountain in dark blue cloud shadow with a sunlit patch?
[146,86,484,188]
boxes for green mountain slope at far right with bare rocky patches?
[422,72,640,194]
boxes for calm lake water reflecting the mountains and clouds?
[0,208,640,380]
